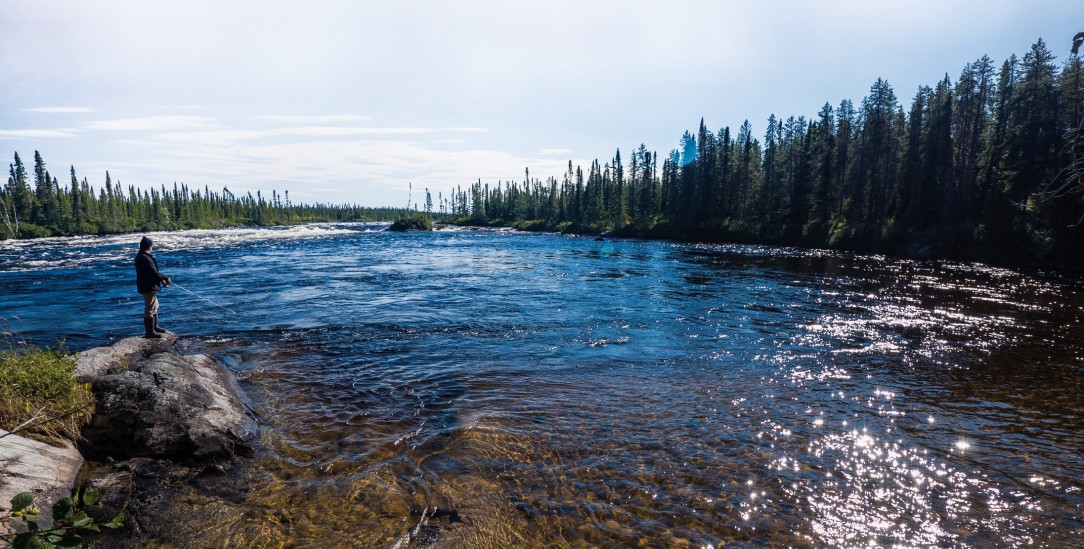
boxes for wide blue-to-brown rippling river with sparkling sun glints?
[0,225,1084,548]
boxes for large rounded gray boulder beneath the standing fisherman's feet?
[77,336,257,460]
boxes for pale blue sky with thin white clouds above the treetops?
[0,0,1084,206]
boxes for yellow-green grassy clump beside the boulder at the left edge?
[0,332,94,442]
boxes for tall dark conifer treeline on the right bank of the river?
[441,40,1084,268]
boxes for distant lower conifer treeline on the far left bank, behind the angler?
[0,151,402,240]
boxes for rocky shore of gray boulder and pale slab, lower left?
[0,332,258,538]
